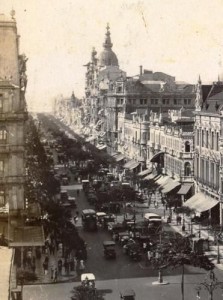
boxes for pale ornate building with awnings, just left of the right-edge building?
[148,109,194,201]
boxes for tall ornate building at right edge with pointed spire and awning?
[192,78,223,224]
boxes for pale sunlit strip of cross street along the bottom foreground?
[24,273,221,300]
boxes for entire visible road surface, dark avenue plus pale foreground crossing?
[24,115,223,300]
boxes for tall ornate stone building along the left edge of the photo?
[0,11,27,227]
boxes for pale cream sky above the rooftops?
[0,0,223,111]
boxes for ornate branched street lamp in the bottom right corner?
[196,271,223,300]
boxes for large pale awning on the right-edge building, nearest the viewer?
[183,192,219,213]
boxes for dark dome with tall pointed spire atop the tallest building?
[99,26,118,67]
